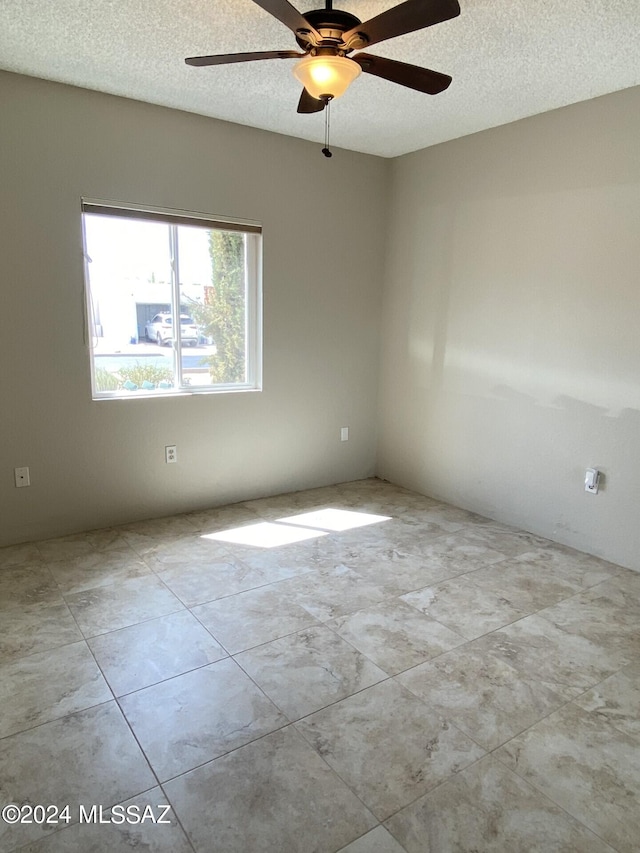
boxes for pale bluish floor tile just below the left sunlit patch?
[158,557,268,607]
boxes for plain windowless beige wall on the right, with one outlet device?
[378,89,640,569]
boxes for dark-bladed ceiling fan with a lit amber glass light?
[185,0,460,113]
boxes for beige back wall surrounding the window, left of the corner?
[0,74,389,544]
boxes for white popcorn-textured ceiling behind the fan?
[0,0,640,157]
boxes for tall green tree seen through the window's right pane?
[191,229,246,383]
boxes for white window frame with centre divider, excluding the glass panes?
[81,198,262,400]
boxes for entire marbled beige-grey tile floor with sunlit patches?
[0,480,640,853]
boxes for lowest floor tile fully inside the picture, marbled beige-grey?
[296,681,484,820]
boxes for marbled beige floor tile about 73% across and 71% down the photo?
[401,575,527,640]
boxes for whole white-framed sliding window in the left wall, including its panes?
[82,200,262,399]
